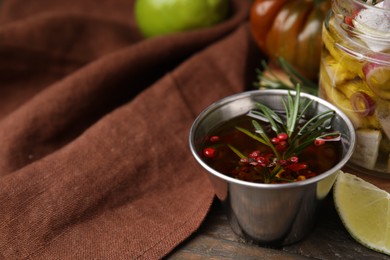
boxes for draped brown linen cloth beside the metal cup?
[0,0,256,259]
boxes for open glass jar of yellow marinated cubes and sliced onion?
[319,0,390,177]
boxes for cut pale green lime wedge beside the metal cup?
[333,171,390,255]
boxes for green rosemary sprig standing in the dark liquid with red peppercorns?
[228,84,340,183]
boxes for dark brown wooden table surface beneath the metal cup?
[167,171,390,260]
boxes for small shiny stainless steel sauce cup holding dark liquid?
[189,90,355,246]
